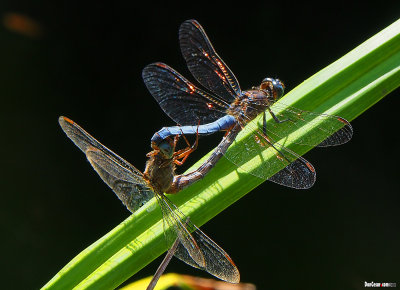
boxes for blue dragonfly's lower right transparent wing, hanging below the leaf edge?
[225,124,316,189]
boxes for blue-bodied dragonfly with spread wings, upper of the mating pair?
[142,20,353,189]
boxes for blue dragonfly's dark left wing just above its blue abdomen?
[142,63,229,125]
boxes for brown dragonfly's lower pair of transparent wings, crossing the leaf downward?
[158,195,240,283]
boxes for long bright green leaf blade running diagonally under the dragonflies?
[44,20,400,289]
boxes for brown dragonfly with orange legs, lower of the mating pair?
[59,116,240,283]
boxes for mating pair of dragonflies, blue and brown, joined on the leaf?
[59,20,352,283]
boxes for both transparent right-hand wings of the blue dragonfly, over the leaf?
[211,103,353,189]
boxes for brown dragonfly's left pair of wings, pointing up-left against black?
[59,117,154,212]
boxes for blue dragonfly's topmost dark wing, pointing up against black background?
[179,20,241,103]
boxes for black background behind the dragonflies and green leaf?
[0,1,400,289]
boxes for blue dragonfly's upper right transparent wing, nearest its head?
[266,103,353,147]
